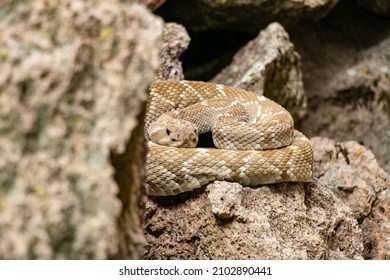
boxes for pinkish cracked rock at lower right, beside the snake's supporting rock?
[311,137,390,259]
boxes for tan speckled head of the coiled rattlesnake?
[147,115,199,148]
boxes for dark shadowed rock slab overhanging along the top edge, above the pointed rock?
[157,0,338,33]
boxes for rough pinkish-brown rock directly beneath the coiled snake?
[144,182,363,259]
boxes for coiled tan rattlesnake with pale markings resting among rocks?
[145,81,313,196]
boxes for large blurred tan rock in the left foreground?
[0,0,162,259]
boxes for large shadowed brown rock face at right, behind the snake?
[290,0,390,173]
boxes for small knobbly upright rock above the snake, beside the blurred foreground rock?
[156,23,190,80]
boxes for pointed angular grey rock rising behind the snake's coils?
[211,23,306,123]
